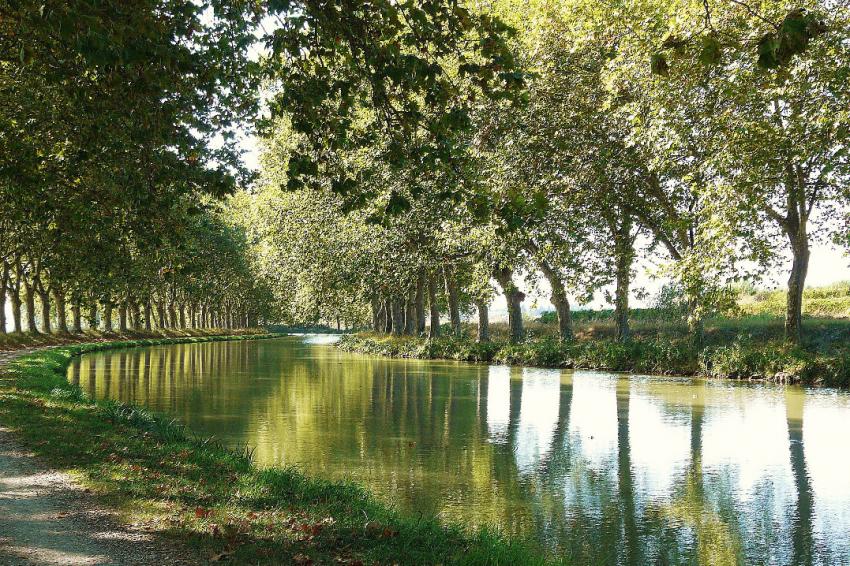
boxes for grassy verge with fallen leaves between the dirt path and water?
[0,336,544,565]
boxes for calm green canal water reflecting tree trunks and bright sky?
[68,337,850,564]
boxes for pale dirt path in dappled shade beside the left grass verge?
[0,351,197,566]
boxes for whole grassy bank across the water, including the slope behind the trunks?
[338,317,850,387]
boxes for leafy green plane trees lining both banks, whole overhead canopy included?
[0,0,850,350]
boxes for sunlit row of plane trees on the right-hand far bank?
[235,0,850,341]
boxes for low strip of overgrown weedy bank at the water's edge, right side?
[337,333,850,387]
